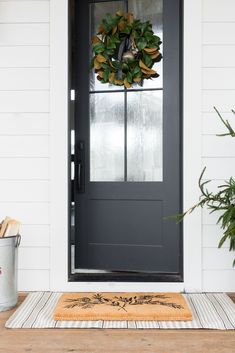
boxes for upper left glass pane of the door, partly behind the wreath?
[90,1,125,91]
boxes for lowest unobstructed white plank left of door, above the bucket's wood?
[0,180,49,202]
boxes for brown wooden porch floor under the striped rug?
[0,294,235,353]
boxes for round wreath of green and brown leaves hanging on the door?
[91,11,162,88]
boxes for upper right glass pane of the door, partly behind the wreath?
[128,0,163,88]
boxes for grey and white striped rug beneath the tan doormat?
[5,292,235,330]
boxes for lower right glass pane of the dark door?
[127,91,163,181]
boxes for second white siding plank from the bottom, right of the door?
[202,248,235,274]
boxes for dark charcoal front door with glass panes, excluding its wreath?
[73,0,182,274]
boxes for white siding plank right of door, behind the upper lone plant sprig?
[202,112,235,135]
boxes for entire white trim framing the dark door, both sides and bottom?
[50,0,202,291]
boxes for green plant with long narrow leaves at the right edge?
[175,107,235,266]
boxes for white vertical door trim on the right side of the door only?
[183,0,202,291]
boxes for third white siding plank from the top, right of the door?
[202,45,235,67]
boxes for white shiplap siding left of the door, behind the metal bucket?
[0,0,50,290]
